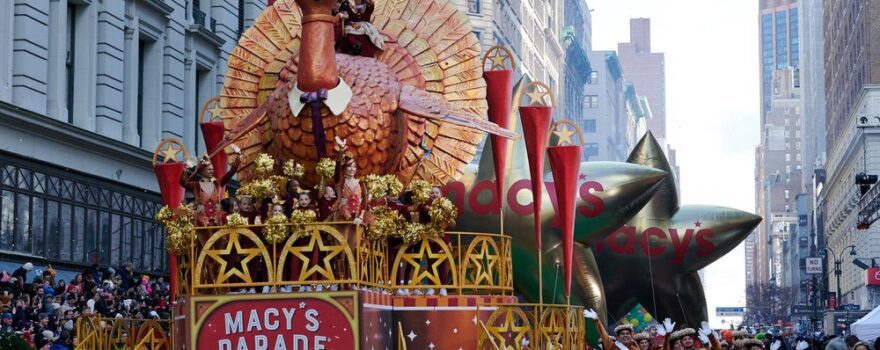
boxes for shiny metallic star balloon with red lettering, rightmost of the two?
[592,133,762,325]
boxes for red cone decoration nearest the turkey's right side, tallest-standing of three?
[483,69,513,213]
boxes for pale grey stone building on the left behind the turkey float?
[0,0,266,279]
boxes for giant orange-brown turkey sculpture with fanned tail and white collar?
[221,0,516,183]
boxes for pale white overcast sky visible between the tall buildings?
[586,0,760,328]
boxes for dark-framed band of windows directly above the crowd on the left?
[0,155,167,272]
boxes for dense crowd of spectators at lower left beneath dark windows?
[0,262,171,350]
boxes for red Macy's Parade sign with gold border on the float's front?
[193,293,358,350]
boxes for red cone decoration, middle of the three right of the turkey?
[519,106,553,250]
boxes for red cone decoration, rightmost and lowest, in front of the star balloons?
[547,146,581,298]
